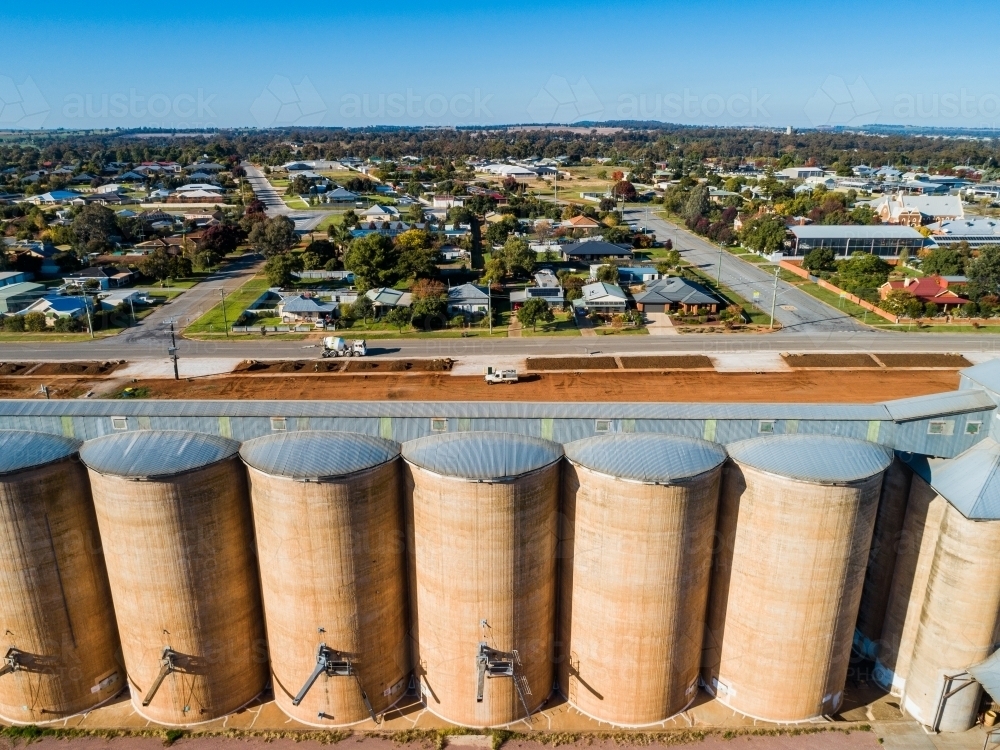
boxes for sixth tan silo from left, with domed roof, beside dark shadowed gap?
[704,435,891,722]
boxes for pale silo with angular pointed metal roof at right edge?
[902,439,1000,732]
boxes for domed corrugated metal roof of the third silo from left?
[240,430,399,480]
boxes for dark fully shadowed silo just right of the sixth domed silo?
[854,458,913,659]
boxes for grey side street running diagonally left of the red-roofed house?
[625,208,870,332]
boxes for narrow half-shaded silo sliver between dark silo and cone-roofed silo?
[873,476,948,695]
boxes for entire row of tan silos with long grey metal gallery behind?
[0,360,1000,731]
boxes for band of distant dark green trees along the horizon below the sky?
[0,123,1000,171]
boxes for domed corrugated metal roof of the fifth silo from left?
[566,432,726,484]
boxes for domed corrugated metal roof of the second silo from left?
[80,430,240,479]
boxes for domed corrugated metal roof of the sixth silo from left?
[728,435,892,484]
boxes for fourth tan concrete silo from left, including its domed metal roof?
[403,432,562,727]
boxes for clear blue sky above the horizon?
[0,0,1000,128]
